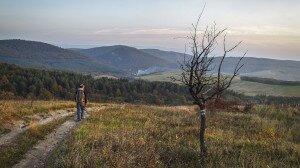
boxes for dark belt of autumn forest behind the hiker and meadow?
[0,63,300,105]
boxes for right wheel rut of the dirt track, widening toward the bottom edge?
[13,107,105,168]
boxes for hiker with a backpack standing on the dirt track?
[75,84,87,121]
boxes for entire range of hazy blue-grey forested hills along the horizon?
[0,40,300,81]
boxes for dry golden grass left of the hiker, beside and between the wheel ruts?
[0,100,75,167]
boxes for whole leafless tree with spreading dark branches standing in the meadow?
[173,8,246,155]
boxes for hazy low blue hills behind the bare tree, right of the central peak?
[142,49,300,81]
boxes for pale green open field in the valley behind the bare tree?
[139,72,300,97]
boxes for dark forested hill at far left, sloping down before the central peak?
[0,40,120,73]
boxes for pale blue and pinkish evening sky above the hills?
[0,0,300,61]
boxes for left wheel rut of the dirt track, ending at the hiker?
[0,110,74,146]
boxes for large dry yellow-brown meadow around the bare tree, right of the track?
[48,104,300,167]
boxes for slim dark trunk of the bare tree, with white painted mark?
[199,105,207,156]
